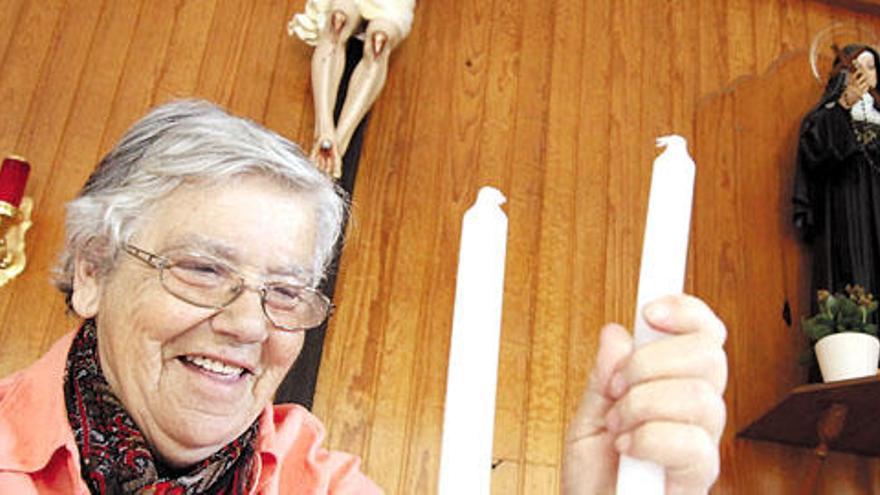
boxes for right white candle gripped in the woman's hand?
[617,135,696,495]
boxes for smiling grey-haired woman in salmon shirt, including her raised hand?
[0,101,726,494]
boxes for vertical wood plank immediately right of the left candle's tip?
[496,2,554,493]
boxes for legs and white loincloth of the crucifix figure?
[288,0,415,179]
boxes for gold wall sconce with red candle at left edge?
[0,156,33,286]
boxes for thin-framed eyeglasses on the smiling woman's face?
[123,244,333,332]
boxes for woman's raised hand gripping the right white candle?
[563,296,727,495]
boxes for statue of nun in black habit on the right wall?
[793,45,880,294]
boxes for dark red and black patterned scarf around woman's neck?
[64,320,257,495]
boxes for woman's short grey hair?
[55,100,346,306]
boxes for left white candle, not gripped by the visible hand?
[438,187,507,495]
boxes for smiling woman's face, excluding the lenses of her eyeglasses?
[73,177,316,466]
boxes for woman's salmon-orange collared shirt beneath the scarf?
[0,332,382,495]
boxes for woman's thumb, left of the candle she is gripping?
[570,324,633,440]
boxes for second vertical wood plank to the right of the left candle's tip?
[525,2,585,476]
